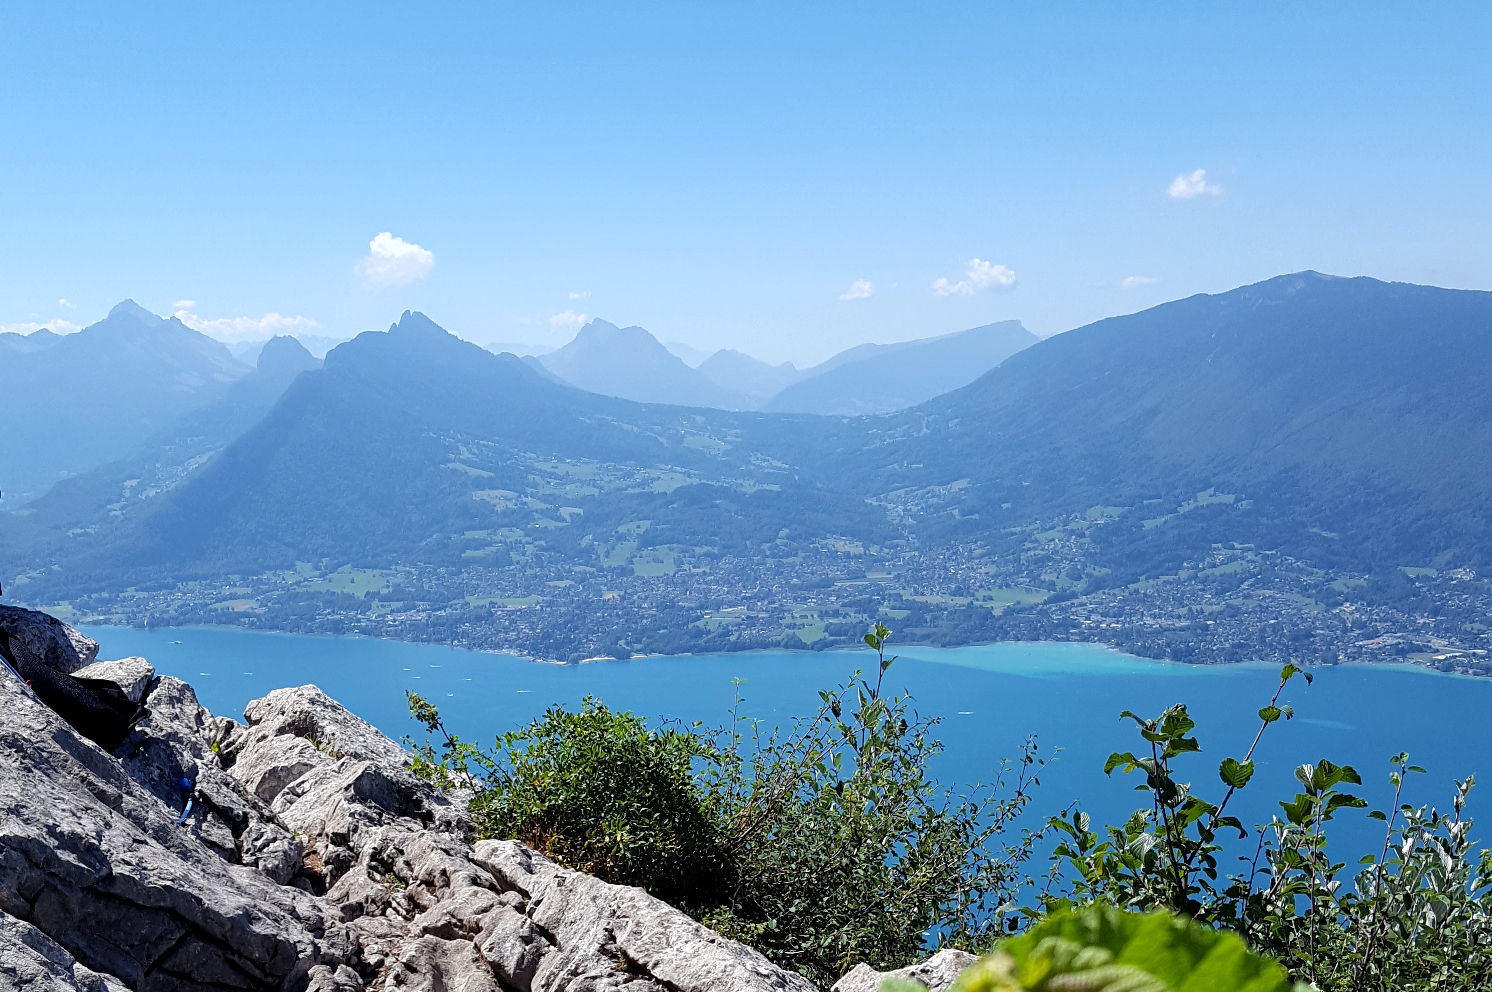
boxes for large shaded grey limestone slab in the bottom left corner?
[0,668,357,992]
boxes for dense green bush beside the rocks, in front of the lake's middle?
[410,627,1041,988]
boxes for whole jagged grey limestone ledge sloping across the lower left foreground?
[0,607,964,992]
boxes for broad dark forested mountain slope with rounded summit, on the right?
[846,273,1492,567]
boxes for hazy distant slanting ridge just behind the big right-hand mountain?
[761,321,1040,416]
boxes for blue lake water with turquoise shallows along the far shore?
[85,627,1492,862]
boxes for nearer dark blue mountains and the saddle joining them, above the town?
[0,273,1492,623]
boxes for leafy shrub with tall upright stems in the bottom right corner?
[1044,665,1492,992]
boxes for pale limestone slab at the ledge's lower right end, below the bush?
[471,840,813,992]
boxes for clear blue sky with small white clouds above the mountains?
[0,3,1492,364]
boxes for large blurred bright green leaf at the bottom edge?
[952,905,1291,992]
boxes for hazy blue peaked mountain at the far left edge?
[0,300,249,503]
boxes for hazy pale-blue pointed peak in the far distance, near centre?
[539,321,746,409]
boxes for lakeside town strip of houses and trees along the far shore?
[40,510,1492,674]
